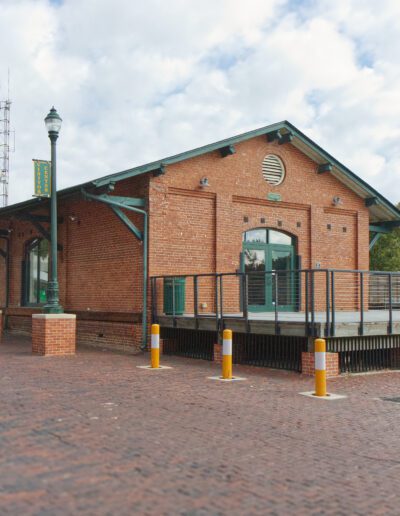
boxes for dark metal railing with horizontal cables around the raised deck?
[150,269,400,337]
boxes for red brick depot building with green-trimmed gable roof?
[0,122,400,366]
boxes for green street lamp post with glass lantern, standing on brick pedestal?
[44,106,64,314]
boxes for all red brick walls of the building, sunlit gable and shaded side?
[0,136,369,346]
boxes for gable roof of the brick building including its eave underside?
[0,120,400,223]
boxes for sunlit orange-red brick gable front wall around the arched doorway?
[149,136,369,311]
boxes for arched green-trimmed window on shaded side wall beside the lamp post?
[24,238,49,305]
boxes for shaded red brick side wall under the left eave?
[0,177,148,350]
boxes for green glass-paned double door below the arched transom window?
[243,242,296,312]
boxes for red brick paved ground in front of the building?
[0,337,400,516]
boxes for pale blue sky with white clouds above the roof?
[0,0,400,204]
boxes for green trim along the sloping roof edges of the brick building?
[0,120,400,220]
